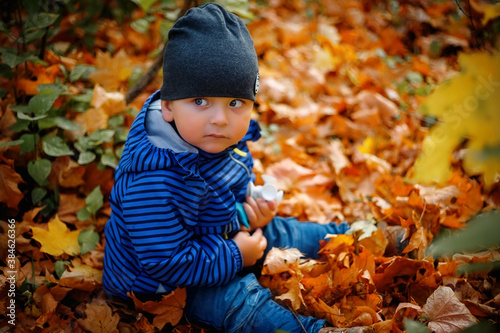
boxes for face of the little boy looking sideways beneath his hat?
[161,97,254,153]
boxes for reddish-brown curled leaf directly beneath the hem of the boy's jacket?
[129,288,186,330]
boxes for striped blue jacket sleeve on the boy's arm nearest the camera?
[122,173,243,287]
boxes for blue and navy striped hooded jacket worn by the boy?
[103,92,260,298]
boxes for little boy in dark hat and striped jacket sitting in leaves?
[103,4,368,333]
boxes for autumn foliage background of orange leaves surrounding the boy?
[0,0,500,332]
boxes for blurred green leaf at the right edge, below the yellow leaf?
[428,211,500,257]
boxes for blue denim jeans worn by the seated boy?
[184,217,349,333]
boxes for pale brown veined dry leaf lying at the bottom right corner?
[423,286,477,333]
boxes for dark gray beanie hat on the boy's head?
[161,3,259,101]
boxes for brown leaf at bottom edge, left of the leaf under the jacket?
[77,303,120,333]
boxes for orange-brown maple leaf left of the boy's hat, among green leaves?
[89,49,132,91]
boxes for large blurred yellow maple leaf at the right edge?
[412,52,500,187]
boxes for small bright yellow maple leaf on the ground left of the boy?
[31,215,80,256]
